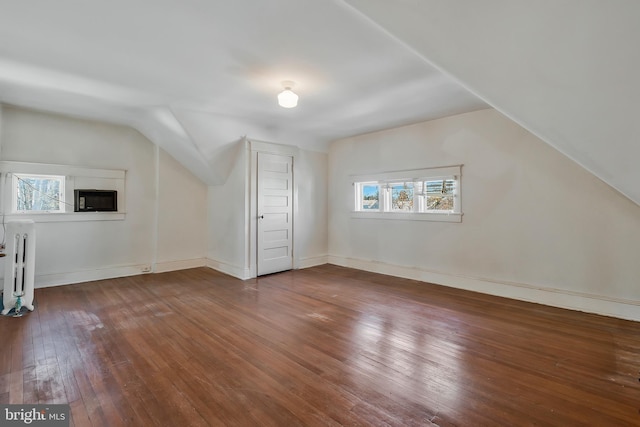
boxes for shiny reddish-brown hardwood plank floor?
[0,265,640,426]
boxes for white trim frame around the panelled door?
[247,139,300,278]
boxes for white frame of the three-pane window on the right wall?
[351,165,463,222]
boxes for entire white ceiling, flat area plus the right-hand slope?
[0,0,640,209]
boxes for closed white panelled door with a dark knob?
[257,153,293,276]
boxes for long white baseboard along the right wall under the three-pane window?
[328,255,640,321]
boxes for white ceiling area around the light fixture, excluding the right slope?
[0,0,487,184]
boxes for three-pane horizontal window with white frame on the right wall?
[353,166,462,222]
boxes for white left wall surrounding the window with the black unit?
[0,105,206,286]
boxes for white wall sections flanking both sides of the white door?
[207,141,328,279]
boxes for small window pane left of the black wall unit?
[12,173,65,213]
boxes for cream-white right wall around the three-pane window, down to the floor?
[329,110,640,320]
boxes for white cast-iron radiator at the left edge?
[2,220,36,314]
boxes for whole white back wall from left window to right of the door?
[0,105,327,287]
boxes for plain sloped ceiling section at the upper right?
[347,0,640,205]
